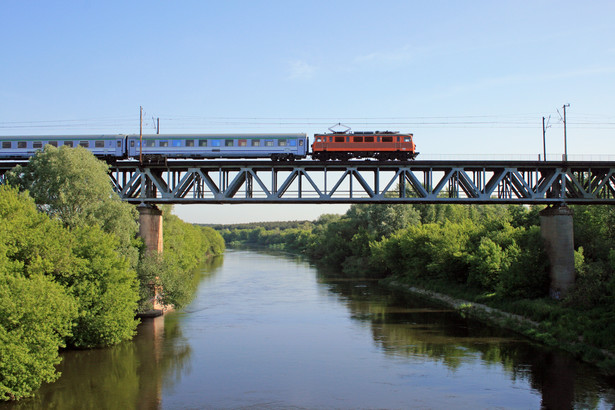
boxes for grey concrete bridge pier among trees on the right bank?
[540,205,575,299]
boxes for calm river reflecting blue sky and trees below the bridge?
[0,250,615,409]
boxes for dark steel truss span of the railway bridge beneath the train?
[0,160,615,205]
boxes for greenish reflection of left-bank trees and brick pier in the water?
[0,257,223,409]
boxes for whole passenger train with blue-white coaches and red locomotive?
[0,131,418,162]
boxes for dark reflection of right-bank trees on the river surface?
[319,272,615,409]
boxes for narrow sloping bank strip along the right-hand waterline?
[380,278,615,375]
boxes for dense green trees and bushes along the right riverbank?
[215,204,615,373]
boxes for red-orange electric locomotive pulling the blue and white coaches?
[311,131,419,161]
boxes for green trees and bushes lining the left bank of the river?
[0,145,224,401]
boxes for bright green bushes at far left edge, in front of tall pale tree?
[0,186,77,400]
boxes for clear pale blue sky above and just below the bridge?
[0,0,615,223]
